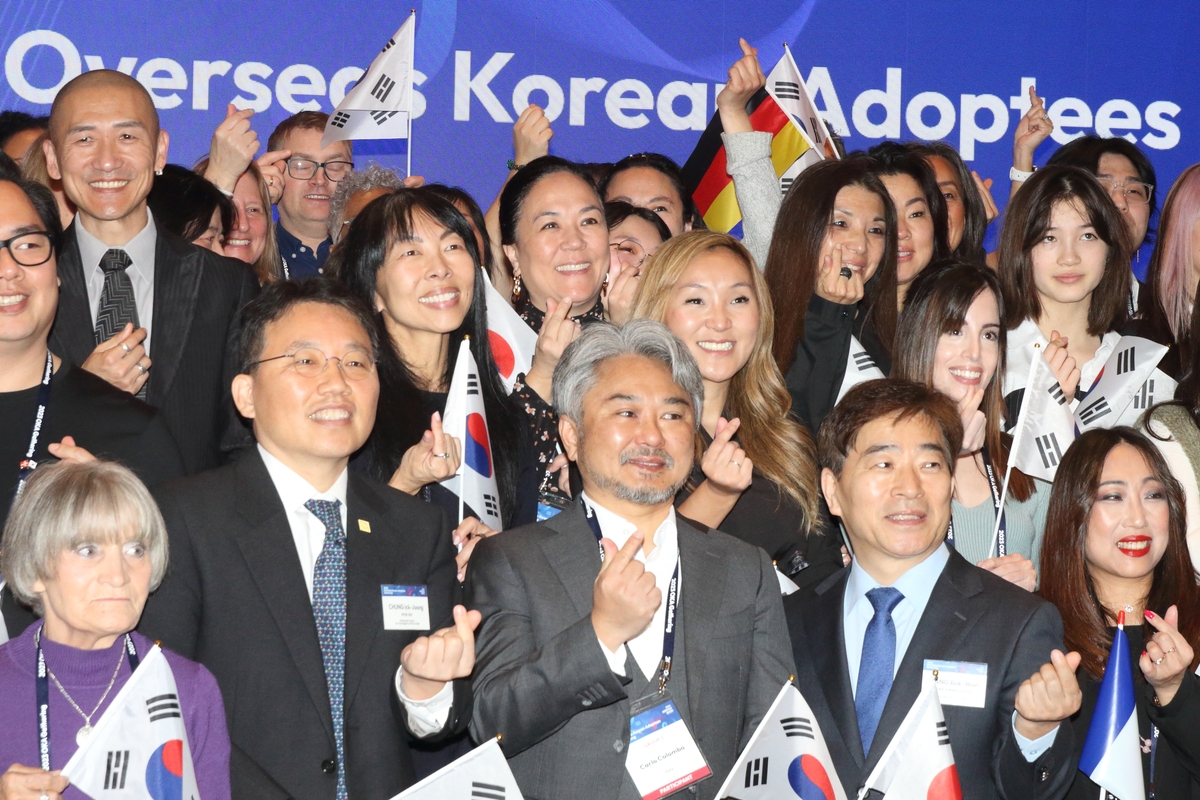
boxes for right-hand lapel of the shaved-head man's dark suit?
[146,235,200,407]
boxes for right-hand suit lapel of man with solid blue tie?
[866,549,984,769]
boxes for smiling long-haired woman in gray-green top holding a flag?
[892,259,1050,591]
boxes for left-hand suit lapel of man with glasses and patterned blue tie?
[236,450,334,741]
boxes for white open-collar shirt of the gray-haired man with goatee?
[583,493,683,679]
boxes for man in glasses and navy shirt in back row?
[266,112,354,281]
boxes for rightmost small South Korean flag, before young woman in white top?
[1075,336,1176,432]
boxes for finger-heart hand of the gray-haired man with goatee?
[592,531,662,652]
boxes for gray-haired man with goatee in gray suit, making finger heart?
[467,319,793,800]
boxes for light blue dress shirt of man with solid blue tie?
[841,543,1058,763]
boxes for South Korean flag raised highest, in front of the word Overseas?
[320,13,416,148]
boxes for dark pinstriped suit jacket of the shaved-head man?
[50,223,258,475]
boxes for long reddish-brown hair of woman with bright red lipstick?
[1038,427,1200,679]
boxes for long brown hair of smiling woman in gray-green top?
[892,258,1033,503]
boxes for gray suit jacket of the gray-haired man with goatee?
[467,504,792,800]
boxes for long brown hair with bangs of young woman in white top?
[1000,167,1132,336]
